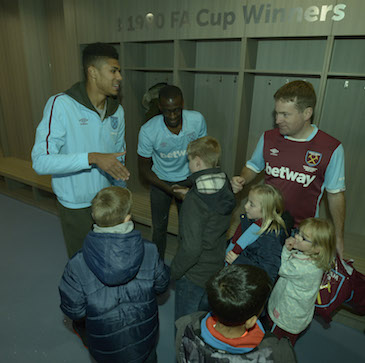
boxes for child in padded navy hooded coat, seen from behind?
[59,186,169,363]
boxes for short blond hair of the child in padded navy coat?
[91,186,132,227]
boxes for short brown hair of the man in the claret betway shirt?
[274,80,317,112]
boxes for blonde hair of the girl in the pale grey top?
[299,218,336,271]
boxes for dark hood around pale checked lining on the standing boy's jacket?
[188,168,236,216]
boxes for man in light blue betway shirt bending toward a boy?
[137,85,207,259]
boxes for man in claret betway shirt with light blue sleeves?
[232,81,345,257]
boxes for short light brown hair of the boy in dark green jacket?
[187,136,221,168]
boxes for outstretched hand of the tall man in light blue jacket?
[89,151,130,180]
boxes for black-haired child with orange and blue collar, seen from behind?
[176,265,296,363]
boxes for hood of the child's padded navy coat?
[82,230,144,286]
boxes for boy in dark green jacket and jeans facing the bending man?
[171,136,236,320]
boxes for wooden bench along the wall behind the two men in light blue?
[0,157,178,234]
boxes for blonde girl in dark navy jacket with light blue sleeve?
[226,184,287,282]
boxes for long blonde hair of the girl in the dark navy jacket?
[250,184,286,235]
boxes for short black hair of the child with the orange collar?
[206,265,272,326]
